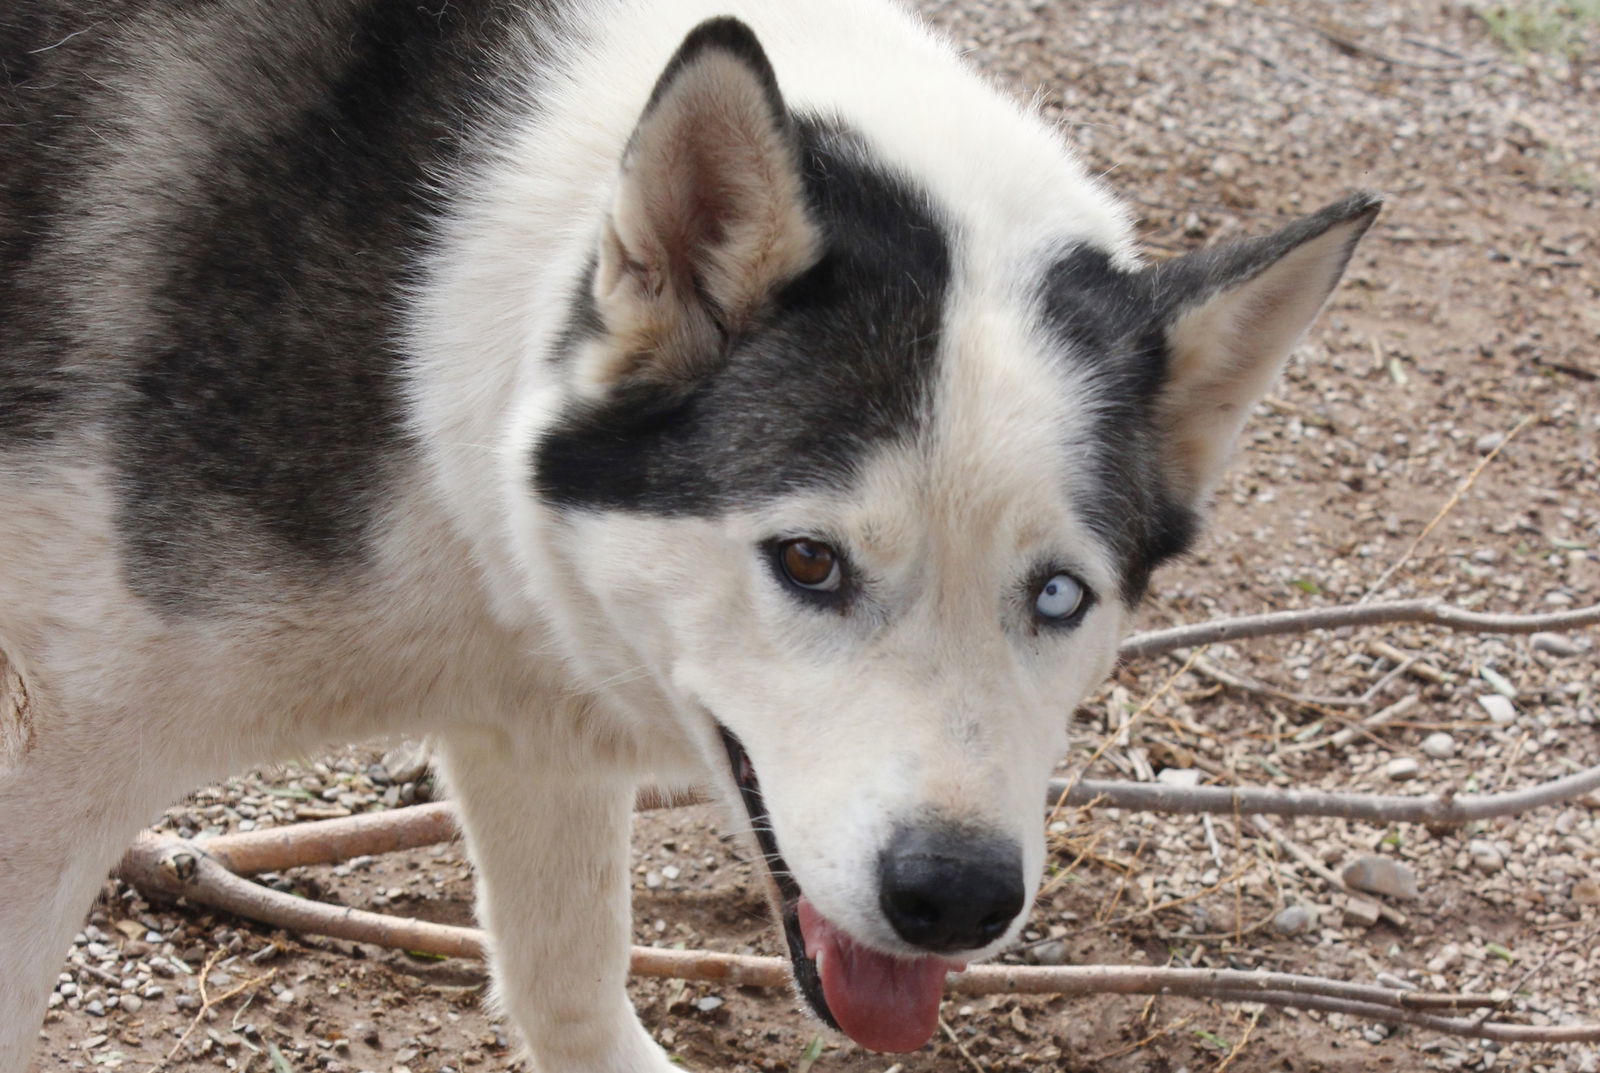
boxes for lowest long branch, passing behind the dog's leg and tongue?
[109,835,1600,1041]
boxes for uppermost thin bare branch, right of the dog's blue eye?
[1118,600,1600,659]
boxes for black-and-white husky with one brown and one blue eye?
[0,0,1378,1073]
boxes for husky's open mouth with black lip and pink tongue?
[717,723,966,1052]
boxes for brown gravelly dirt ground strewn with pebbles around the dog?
[25,0,1600,1073]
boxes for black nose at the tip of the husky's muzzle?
[878,824,1024,953]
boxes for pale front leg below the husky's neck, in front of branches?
[445,732,675,1073]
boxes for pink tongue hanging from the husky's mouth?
[798,899,966,1052]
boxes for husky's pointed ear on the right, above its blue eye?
[1152,193,1382,504]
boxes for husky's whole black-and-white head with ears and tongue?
[533,19,1378,1051]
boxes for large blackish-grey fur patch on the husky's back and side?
[0,0,536,611]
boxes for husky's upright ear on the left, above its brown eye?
[581,18,821,393]
